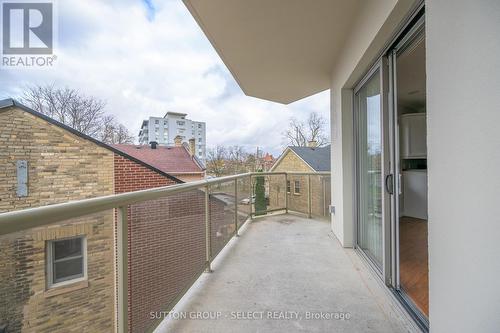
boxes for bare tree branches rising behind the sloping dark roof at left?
[20,84,134,143]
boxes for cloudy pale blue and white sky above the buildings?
[0,0,329,155]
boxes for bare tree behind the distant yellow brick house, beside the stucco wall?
[283,112,328,147]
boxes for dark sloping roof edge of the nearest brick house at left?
[0,98,184,183]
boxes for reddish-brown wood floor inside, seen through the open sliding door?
[399,216,429,317]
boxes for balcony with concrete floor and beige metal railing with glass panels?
[0,173,411,332]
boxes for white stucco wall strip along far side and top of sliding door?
[330,0,417,247]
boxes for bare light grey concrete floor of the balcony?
[157,214,417,333]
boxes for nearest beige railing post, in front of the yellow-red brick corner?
[116,206,128,333]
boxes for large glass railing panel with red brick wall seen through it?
[129,190,207,332]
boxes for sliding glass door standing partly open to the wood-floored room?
[353,5,429,330]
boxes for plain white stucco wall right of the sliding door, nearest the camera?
[426,0,500,333]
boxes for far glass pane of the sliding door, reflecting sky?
[355,69,383,271]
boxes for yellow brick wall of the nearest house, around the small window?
[0,108,115,332]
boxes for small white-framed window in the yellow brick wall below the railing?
[47,236,87,288]
